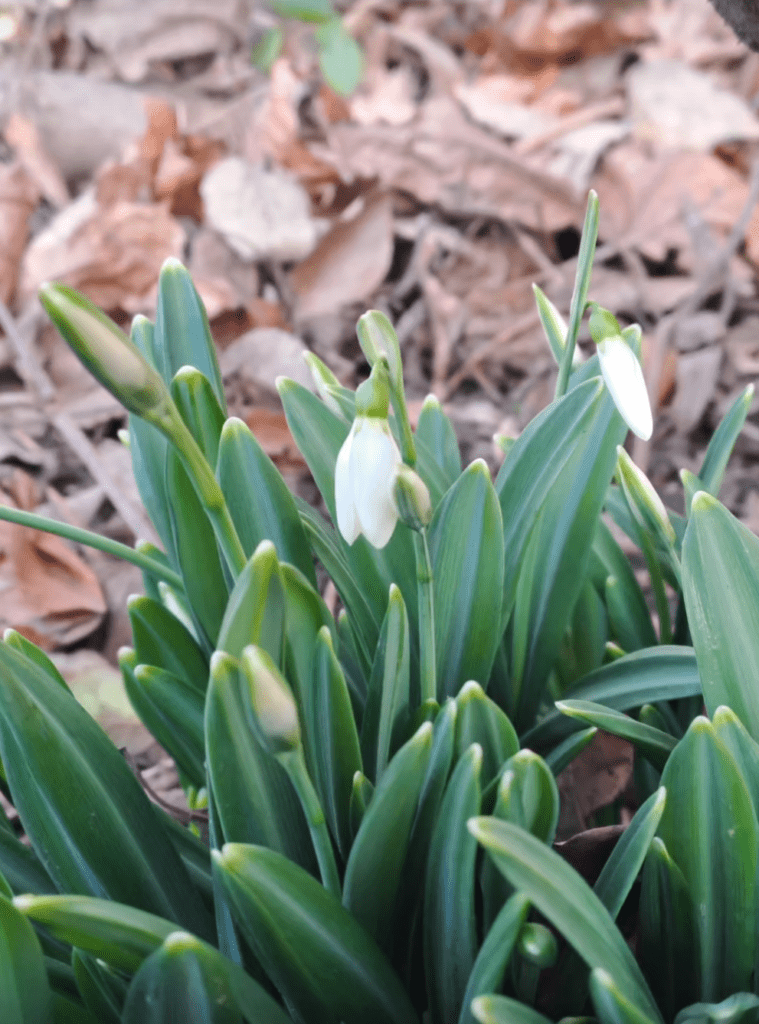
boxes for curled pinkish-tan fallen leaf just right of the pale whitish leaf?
[290,195,392,318]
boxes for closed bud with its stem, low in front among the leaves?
[239,644,341,899]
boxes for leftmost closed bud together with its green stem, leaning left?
[39,284,246,578]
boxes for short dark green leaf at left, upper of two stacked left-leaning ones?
[127,595,208,693]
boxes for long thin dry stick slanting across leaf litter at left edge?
[0,301,155,540]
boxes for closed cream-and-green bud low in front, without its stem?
[240,644,300,756]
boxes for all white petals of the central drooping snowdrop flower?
[335,416,402,548]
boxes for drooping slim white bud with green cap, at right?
[589,302,653,441]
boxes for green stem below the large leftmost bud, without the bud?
[150,399,248,580]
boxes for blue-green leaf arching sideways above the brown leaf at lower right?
[521,646,701,752]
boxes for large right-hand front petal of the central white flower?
[350,418,402,548]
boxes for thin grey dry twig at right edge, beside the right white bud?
[632,159,759,472]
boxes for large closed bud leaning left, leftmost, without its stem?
[39,284,169,417]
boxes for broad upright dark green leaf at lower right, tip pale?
[660,717,759,1001]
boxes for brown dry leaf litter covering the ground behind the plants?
[0,0,759,830]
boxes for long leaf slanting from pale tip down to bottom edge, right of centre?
[469,818,662,1024]
